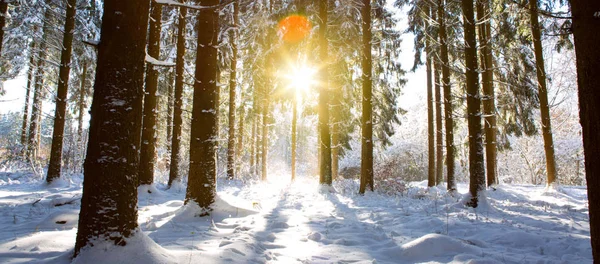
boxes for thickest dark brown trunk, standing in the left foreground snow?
[74,0,149,256]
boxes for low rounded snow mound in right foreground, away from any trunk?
[401,234,481,262]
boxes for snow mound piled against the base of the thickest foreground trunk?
[72,231,177,264]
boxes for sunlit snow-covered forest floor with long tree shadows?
[0,172,592,264]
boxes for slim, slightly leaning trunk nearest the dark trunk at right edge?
[529,0,556,186]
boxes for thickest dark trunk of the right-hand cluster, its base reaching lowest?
[462,0,485,208]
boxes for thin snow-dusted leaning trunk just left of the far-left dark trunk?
[27,7,52,161]
